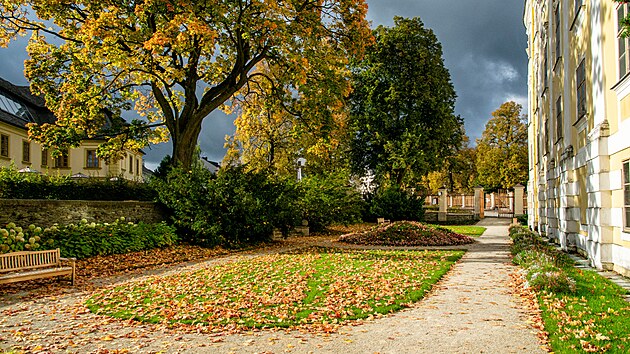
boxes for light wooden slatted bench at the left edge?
[0,248,76,285]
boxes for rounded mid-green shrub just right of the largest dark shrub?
[298,173,365,231]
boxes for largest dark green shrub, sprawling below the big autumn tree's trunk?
[152,166,300,247]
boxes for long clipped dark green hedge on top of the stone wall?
[0,166,156,201]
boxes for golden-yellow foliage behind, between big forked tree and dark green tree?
[224,60,350,175]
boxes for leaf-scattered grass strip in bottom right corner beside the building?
[538,269,630,353]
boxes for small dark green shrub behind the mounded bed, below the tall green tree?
[370,186,424,221]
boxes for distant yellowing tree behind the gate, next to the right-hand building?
[477,101,528,189]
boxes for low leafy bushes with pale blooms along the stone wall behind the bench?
[0,219,177,259]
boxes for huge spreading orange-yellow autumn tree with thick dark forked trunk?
[0,0,371,166]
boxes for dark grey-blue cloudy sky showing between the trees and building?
[0,0,527,168]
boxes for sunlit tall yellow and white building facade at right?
[524,0,630,275]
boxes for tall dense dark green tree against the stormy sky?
[351,17,462,186]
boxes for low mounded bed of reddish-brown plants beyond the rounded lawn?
[339,221,475,246]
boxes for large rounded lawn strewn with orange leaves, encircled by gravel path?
[87,248,464,328]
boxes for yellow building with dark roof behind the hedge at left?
[0,79,144,180]
